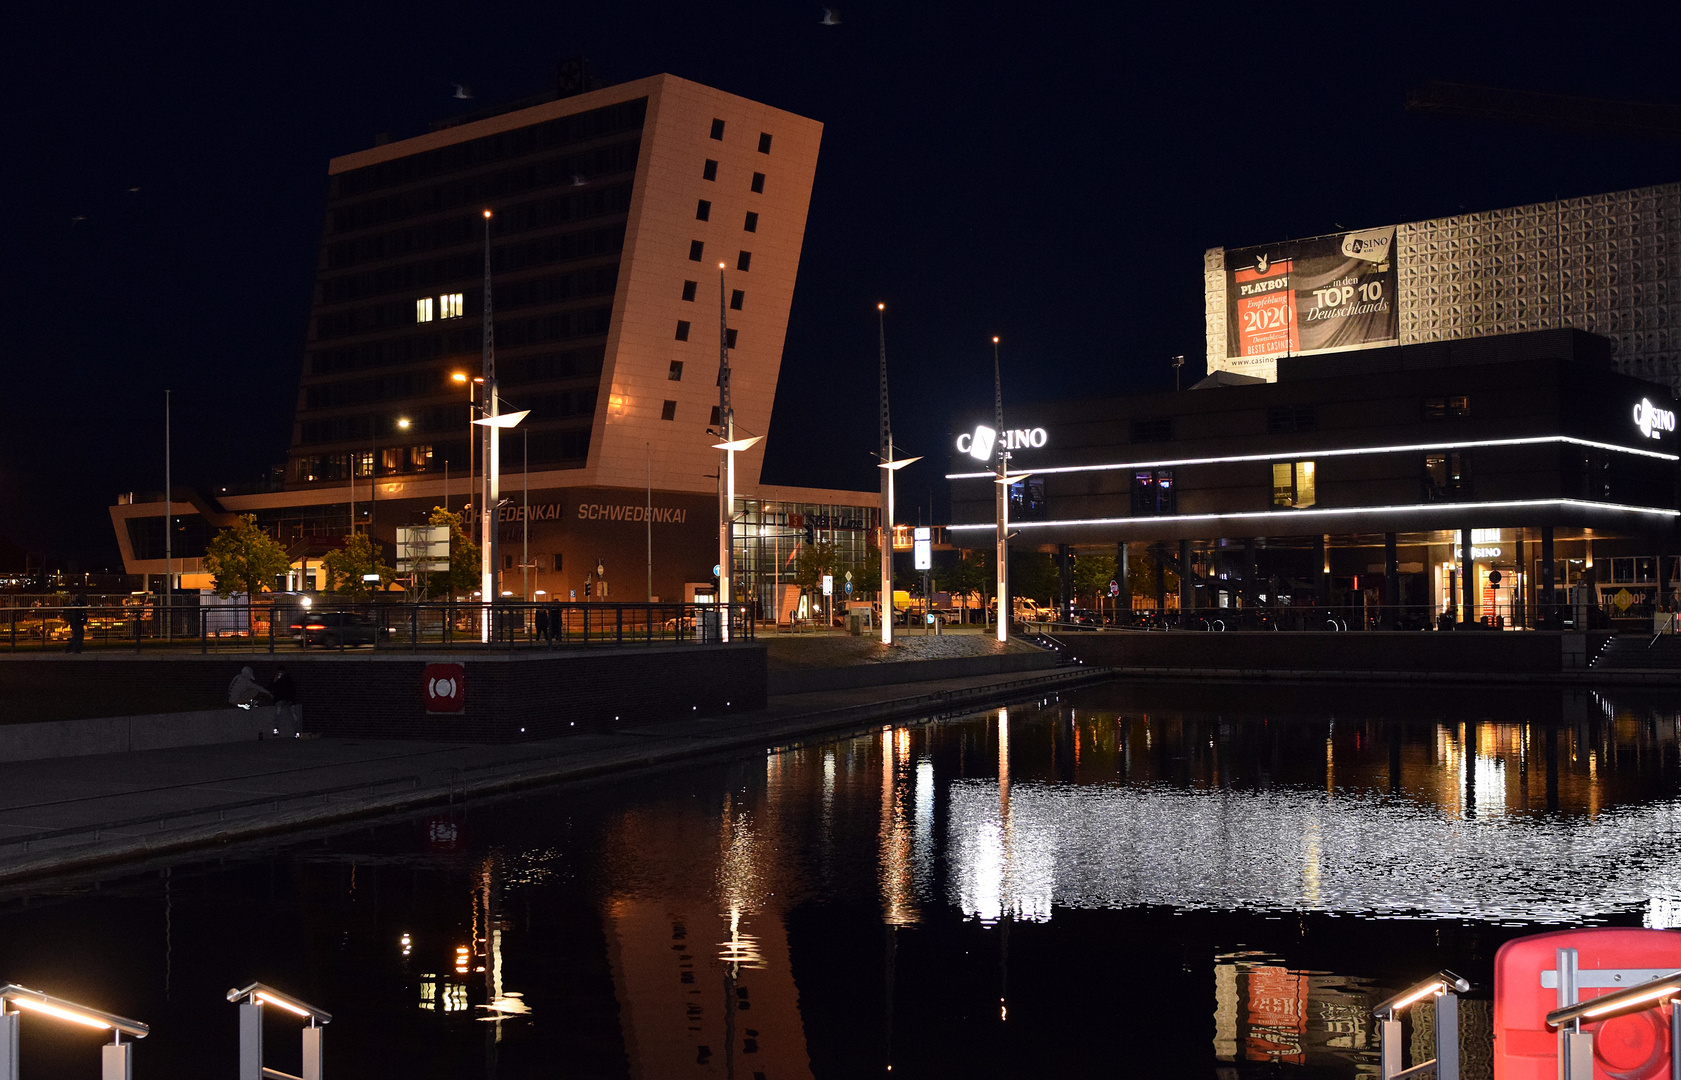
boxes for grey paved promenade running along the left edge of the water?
[0,656,1109,881]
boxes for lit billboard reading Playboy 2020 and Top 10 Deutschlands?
[1222,227,1400,379]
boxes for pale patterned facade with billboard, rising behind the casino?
[1204,183,1681,390]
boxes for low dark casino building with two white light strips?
[948,330,1681,626]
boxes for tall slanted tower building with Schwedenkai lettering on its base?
[111,72,877,614]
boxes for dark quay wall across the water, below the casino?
[1057,631,1610,675]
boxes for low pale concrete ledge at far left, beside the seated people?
[0,708,277,762]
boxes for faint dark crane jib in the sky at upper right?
[1407,82,1681,138]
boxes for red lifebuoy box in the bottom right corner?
[1494,927,1681,1080]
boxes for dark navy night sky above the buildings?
[0,0,1681,570]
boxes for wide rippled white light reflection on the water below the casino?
[946,777,1681,925]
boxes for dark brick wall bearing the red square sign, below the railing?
[0,643,767,742]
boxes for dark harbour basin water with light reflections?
[0,686,1681,1080]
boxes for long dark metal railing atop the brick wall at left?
[0,596,756,653]
